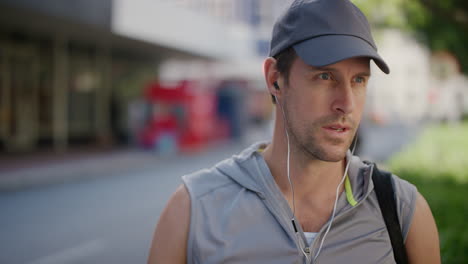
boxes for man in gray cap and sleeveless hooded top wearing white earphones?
[148,0,440,264]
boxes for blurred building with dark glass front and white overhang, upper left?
[0,0,284,153]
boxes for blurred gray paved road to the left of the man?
[0,142,247,264]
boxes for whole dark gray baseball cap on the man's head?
[270,0,390,74]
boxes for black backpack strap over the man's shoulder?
[372,164,408,264]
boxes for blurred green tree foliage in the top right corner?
[353,0,468,74]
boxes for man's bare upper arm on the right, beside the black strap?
[406,193,441,264]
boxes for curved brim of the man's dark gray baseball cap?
[293,35,390,74]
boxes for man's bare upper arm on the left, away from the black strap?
[148,185,190,264]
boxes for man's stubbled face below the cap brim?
[280,57,370,162]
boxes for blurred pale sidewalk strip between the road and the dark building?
[0,142,245,192]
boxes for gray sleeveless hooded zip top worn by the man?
[182,143,417,264]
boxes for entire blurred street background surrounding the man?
[0,0,468,264]
